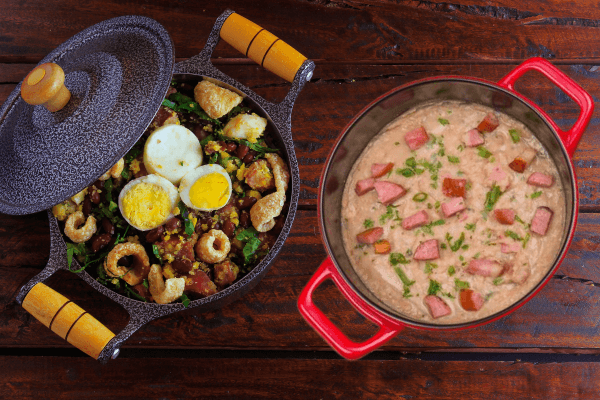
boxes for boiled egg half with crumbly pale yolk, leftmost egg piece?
[119,174,179,231]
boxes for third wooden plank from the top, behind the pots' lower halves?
[0,211,600,353]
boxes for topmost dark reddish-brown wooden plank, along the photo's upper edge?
[0,0,600,62]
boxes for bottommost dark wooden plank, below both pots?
[0,356,600,400]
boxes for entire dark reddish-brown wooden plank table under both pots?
[0,0,600,399]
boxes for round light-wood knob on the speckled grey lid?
[21,63,71,112]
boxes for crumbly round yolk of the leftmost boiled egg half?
[122,182,171,229]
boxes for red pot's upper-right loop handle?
[498,57,594,157]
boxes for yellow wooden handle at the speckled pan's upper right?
[221,13,306,82]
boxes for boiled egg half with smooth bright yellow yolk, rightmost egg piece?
[179,164,231,211]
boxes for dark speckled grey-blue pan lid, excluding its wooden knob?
[0,16,175,215]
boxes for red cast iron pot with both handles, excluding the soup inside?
[298,58,594,359]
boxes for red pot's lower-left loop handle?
[298,257,405,360]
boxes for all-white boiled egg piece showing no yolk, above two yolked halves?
[144,125,202,185]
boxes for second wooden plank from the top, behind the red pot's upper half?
[0,64,600,212]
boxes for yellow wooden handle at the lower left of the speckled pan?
[23,282,115,359]
